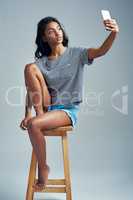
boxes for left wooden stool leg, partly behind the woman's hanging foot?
[26,150,37,200]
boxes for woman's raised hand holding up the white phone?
[103,19,119,33]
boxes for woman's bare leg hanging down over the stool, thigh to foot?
[28,110,71,189]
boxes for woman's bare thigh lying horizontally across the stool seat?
[28,110,71,131]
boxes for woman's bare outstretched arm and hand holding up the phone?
[88,19,119,59]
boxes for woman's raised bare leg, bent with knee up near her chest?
[25,64,51,115]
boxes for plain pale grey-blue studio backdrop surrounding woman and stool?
[0,0,133,200]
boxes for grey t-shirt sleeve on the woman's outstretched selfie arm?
[79,47,94,65]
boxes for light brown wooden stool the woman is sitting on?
[26,126,73,200]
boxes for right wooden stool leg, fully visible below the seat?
[62,135,72,200]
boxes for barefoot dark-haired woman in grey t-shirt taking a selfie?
[20,17,119,189]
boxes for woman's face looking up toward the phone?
[44,22,63,46]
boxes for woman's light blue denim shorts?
[48,104,79,127]
